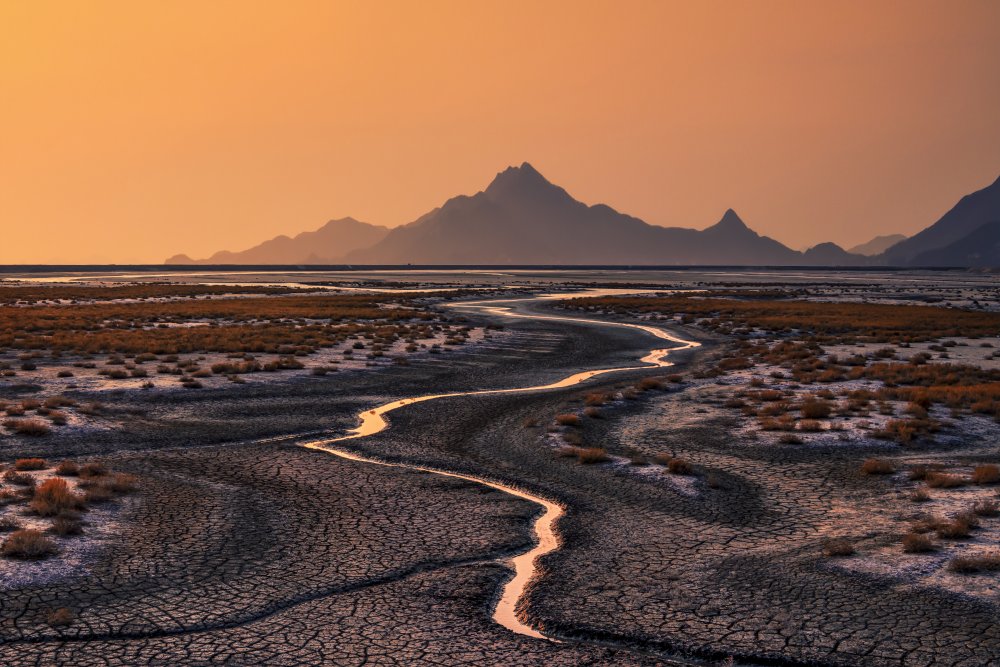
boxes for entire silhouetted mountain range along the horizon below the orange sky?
[166,162,1000,266]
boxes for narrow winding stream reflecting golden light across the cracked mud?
[303,295,700,641]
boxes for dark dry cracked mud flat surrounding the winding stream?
[0,298,1000,666]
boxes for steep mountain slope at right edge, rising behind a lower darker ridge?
[879,178,1000,266]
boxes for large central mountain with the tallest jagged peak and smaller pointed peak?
[347,162,802,265]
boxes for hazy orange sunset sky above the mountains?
[0,0,1000,263]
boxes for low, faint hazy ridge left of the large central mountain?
[165,218,389,264]
